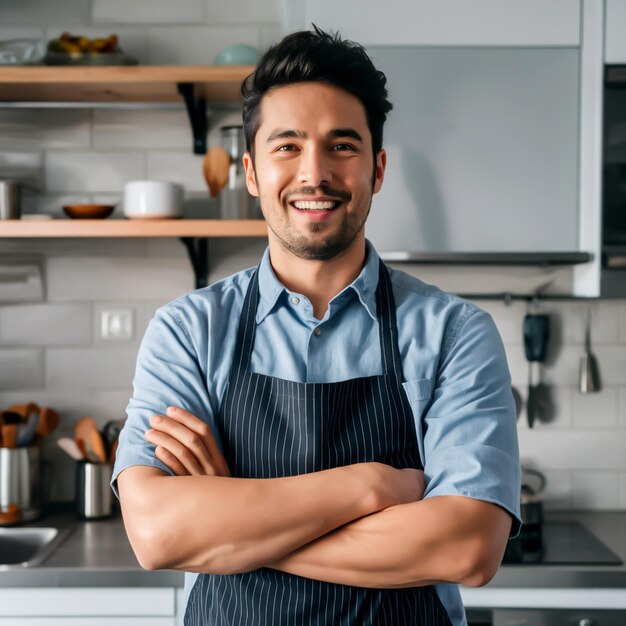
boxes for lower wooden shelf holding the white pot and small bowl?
[0,219,267,238]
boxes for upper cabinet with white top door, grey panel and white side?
[306,0,604,296]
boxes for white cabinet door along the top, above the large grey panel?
[305,0,580,46]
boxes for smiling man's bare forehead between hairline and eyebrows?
[257,82,369,140]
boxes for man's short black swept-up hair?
[241,25,392,162]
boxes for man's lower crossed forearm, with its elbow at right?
[269,496,511,588]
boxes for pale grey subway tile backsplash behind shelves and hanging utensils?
[0,0,626,509]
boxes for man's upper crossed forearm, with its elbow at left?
[118,464,388,573]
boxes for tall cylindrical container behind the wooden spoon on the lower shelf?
[219,126,262,220]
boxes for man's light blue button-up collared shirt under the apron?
[113,242,520,626]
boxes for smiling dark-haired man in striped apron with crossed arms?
[114,29,519,626]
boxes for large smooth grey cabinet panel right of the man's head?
[366,47,579,253]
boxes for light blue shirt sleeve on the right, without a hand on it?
[422,308,521,536]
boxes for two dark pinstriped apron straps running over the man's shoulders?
[233,261,403,381]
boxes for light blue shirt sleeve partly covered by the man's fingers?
[111,308,219,497]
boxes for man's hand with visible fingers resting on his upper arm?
[144,406,230,476]
